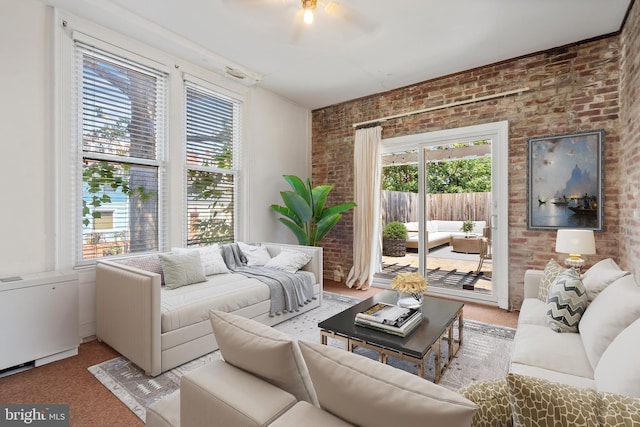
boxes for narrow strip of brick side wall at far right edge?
[619,2,640,277]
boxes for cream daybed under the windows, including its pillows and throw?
[96,243,322,376]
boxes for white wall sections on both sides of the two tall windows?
[0,0,311,337]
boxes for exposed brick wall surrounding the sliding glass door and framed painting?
[312,34,624,308]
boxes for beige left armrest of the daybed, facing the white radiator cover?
[96,261,162,376]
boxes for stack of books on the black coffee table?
[355,302,422,337]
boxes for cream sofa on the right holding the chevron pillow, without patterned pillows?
[509,259,640,398]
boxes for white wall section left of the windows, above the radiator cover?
[0,0,54,277]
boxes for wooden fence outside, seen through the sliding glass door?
[381,190,491,224]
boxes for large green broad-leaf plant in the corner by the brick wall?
[271,175,356,246]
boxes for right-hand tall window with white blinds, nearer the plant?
[186,83,240,245]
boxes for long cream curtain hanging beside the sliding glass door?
[347,126,382,290]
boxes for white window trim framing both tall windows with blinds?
[55,8,249,269]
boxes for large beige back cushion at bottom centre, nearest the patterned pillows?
[299,341,477,427]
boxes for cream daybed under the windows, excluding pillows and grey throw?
[96,243,322,376]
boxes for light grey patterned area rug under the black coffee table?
[88,292,515,421]
